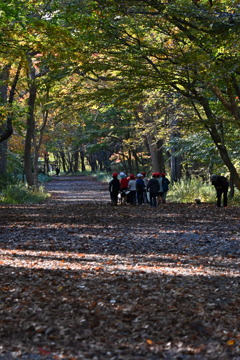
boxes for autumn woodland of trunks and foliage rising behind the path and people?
[0,0,240,200]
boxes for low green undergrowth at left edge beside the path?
[1,183,49,204]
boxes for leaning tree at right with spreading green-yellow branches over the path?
[77,0,240,189]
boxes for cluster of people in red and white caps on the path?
[109,172,170,207]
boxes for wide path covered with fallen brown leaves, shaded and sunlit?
[0,177,240,360]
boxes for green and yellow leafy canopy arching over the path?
[0,0,240,188]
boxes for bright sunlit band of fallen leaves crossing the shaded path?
[0,249,240,277]
